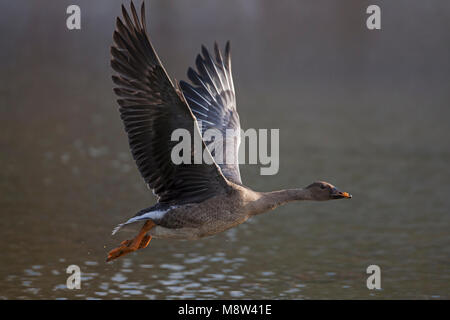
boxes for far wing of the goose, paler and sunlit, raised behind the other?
[180,42,242,184]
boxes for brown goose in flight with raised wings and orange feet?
[106,2,351,261]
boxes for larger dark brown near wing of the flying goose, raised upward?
[111,3,227,204]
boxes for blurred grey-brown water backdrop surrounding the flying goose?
[0,0,450,299]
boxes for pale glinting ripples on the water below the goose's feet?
[5,252,304,299]
